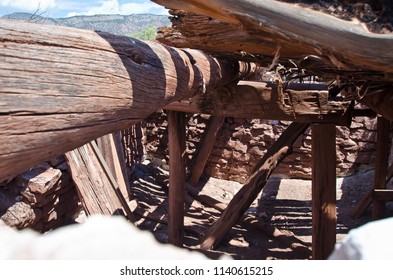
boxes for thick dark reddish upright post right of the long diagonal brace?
[312,124,337,259]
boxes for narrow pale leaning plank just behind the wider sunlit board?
[96,133,130,201]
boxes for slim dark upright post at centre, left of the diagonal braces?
[168,111,186,246]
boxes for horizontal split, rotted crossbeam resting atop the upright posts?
[165,81,351,125]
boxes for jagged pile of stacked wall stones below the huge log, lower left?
[0,157,78,232]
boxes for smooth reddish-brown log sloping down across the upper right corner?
[154,0,393,74]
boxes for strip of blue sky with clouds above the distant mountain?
[0,0,167,18]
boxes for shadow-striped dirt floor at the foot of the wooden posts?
[132,161,393,259]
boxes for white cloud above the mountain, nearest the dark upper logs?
[67,0,167,17]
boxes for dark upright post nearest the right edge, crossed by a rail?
[372,117,390,220]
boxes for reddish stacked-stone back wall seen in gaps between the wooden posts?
[143,110,382,183]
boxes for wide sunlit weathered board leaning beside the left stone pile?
[65,141,133,220]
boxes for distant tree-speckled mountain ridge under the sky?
[2,13,170,35]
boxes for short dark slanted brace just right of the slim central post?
[188,117,225,186]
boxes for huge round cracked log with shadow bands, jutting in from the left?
[0,20,239,181]
